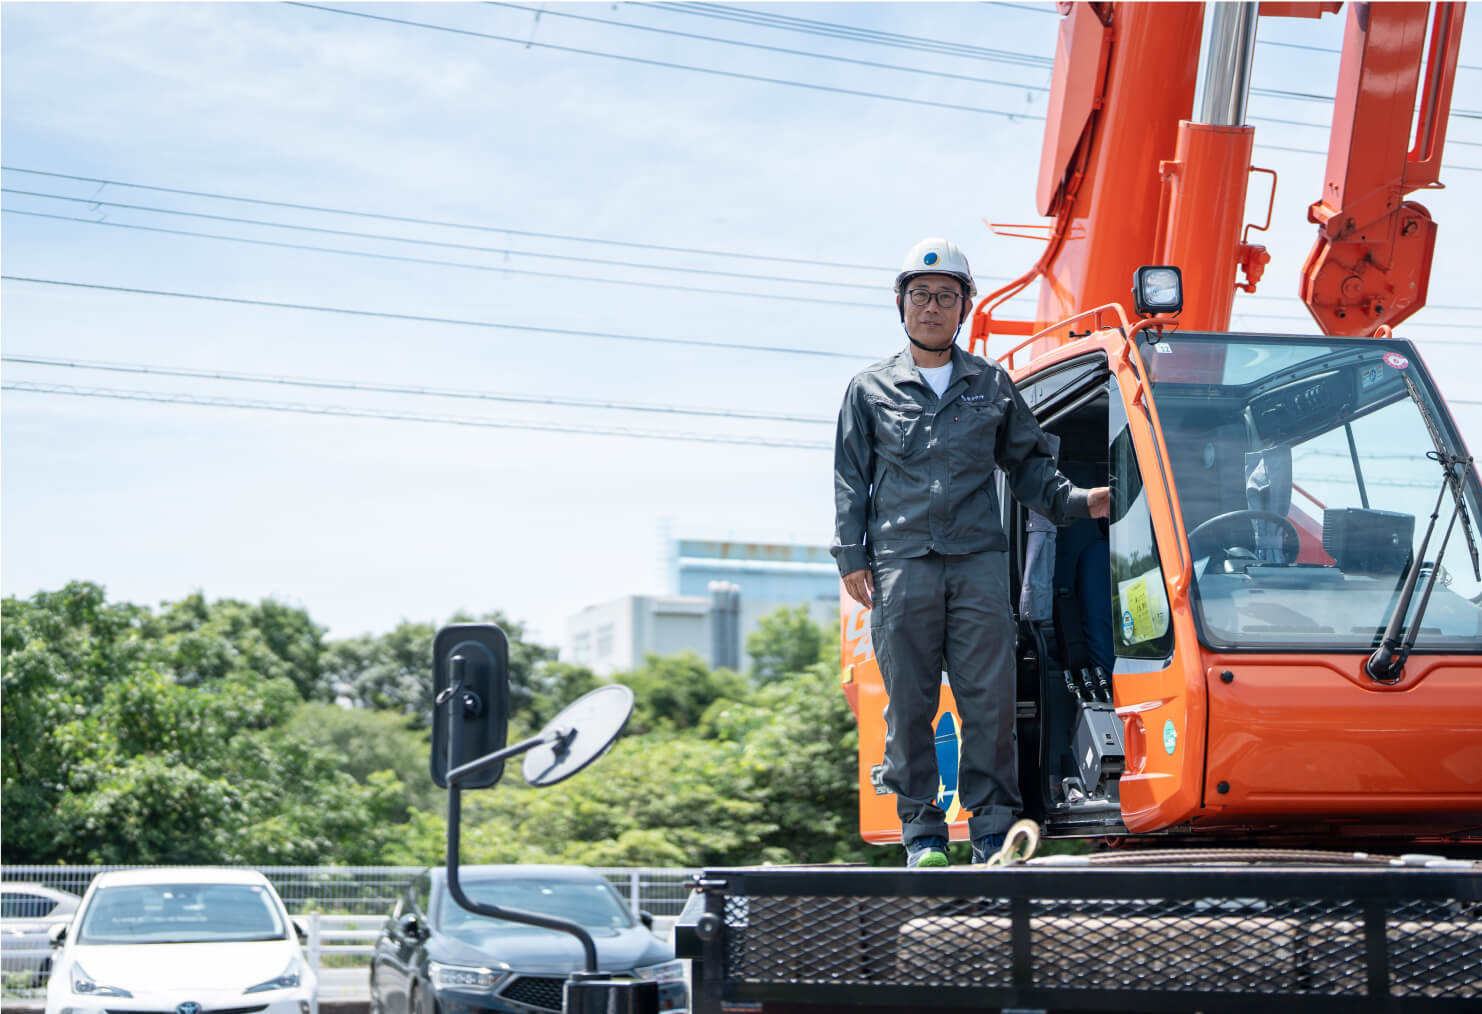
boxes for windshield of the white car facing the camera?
[77,884,288,944]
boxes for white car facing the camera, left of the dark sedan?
[46,869,319,1014]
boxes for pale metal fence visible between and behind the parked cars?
[0,866,698,999]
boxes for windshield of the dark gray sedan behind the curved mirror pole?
[439,878,633,938]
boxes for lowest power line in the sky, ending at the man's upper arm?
[0,381,833,451]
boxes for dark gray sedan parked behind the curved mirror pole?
[371,866,689,1014]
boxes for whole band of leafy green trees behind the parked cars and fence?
[0,581,898,866]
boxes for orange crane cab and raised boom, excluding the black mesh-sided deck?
[842,3,1482,846]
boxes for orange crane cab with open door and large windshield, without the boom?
[842,308,1482,845]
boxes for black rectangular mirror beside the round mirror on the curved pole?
[431,623,510,789]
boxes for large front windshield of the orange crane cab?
[1146,335,1482,652]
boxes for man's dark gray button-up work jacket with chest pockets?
[833,345,1091,574]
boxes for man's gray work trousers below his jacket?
[870,551,1021,842]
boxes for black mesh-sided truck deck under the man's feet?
[676,860,1482,1014]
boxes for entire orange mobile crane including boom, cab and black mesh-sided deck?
[677,3,1482,1014]
